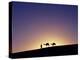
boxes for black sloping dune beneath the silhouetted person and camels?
[9,44,78,58]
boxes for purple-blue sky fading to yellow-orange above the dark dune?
[12,2,78,53]
